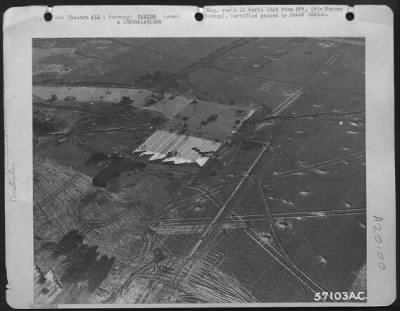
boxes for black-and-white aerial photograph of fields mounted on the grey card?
[33,37,367,305]
